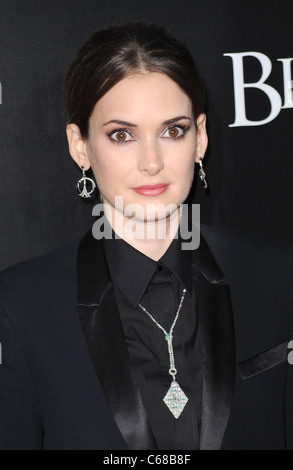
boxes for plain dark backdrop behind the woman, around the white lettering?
[0,0,293,269]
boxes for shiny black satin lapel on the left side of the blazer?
[78,229,156,450]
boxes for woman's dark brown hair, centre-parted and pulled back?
[65,22,205,138]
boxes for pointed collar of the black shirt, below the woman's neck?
[103,235,192,307]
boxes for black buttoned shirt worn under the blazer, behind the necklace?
[103,233,202,450]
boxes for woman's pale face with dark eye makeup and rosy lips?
[67,73,207,222]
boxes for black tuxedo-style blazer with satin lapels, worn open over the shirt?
[0,226,293,450]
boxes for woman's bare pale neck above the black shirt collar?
[104,204,180,261]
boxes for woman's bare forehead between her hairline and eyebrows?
[92,72,192,123]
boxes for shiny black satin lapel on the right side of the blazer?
[192,239,235,450]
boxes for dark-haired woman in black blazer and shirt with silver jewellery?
[0,23,292,450]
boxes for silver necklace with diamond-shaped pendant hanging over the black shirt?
[138,289,188,419]
